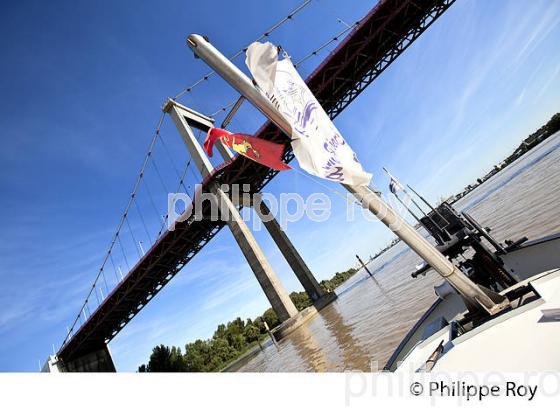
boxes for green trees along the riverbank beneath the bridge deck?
[138,268,356,373]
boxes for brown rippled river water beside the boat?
[239,133,560,372]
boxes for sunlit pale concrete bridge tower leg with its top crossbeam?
[163,100,298,322]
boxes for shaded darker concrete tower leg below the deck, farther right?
[254,201,325,301]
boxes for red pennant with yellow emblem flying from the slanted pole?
[203,128,292,171]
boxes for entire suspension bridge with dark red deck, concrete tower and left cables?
[43,0,455,372]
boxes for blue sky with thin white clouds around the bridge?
[0,0,560,371]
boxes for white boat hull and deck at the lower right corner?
[385,234,560,372]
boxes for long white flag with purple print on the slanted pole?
[245,42,371,185]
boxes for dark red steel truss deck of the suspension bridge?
[58,0,455,363]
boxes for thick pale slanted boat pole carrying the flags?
[187,34,509,314]
